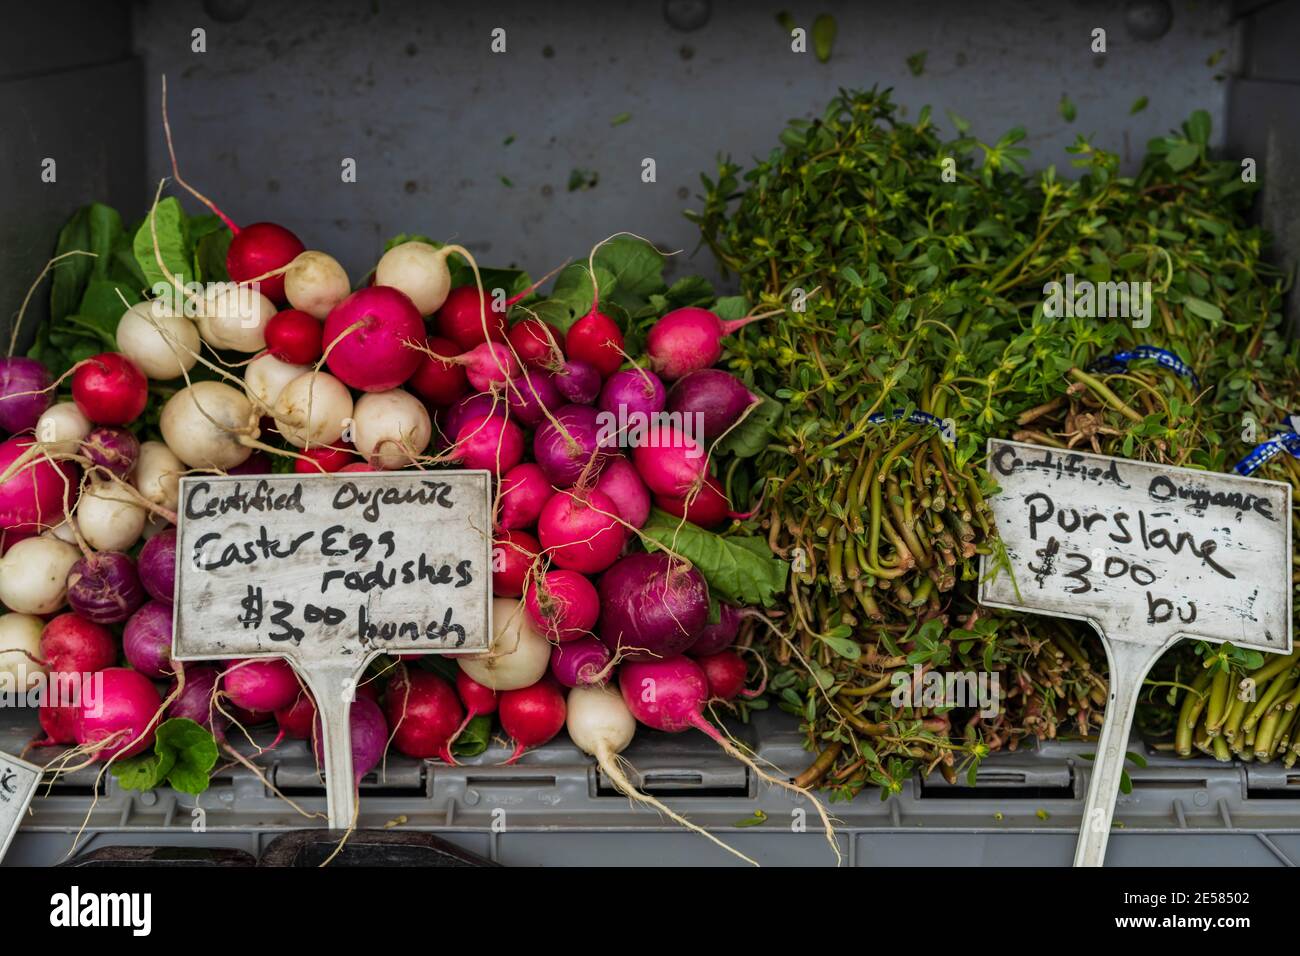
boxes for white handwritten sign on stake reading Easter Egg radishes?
[173,471,491,829]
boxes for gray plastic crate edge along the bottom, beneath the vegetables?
[10,713,1300,866]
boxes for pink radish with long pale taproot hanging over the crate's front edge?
[619,657,842,862]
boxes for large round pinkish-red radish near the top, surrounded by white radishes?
[324,286,424,392]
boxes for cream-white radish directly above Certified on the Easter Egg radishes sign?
[159,381,260,471]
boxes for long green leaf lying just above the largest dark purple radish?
[641,509,789,607]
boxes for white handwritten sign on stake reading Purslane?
[980,438,1292,866]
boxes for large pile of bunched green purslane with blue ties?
[690,90,1300,796]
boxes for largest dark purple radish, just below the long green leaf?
[599,551,709,661]
